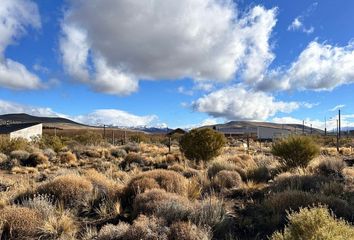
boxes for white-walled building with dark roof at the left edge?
[0,123,43,141]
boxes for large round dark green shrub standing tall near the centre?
[180,128,226,162]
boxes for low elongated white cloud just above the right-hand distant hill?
[192,86,301,120]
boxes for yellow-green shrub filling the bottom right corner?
[271,207,354,240]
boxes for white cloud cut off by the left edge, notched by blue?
[0,0,41,89]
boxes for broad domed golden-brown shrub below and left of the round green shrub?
[125,169,188,204]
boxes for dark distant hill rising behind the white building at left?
[0,113,86,126]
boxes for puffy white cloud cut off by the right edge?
[258,41,354,91]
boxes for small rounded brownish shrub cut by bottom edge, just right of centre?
[169,222,211,240]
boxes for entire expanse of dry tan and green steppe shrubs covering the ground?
[0,131,354,240]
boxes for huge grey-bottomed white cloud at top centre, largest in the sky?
[60,0,276,95]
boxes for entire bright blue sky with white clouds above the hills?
[0,0,354,129]
